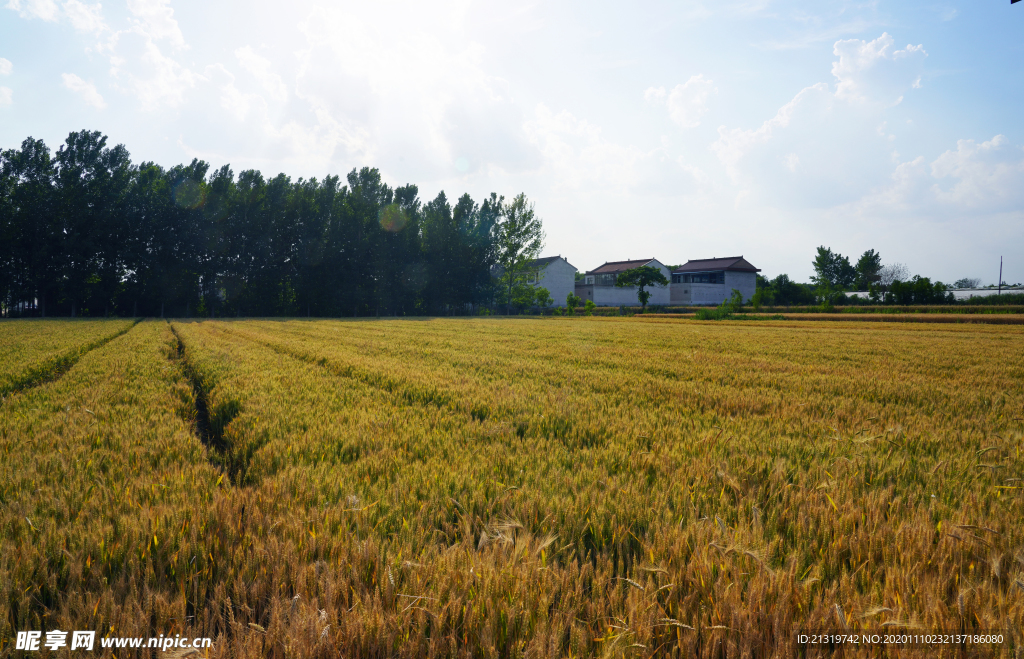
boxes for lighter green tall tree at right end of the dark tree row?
[495,192,544,313]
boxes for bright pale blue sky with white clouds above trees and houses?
[0,0,1024,283]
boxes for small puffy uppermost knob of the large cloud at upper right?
[831,32,928,105]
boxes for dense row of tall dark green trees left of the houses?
[0,131,544,317]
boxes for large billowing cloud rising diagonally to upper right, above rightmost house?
[711,33,926,209]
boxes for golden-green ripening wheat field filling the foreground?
[0,317,1024,658]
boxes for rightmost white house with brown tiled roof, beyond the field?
[669,256,761,305]
